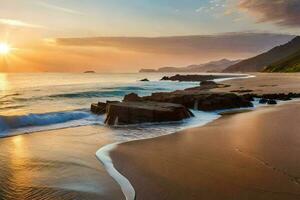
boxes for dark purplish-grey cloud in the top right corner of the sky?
[239,0,300,27]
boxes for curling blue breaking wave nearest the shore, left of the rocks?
[0,110,91,132]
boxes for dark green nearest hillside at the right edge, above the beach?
[264,50,300,72]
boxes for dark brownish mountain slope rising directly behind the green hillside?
[223,36,300,72]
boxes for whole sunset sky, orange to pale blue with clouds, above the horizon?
[0,0,300,72]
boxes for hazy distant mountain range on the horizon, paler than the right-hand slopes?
[140,59,240,72]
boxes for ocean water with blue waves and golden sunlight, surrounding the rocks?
[0,73,224,141]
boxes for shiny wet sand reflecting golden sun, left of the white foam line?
[0,126,124,200]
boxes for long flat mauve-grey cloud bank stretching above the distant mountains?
[56,32,293,56]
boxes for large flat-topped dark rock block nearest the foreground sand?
[105,102,193,125]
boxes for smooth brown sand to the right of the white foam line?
[111,101,300,200]
